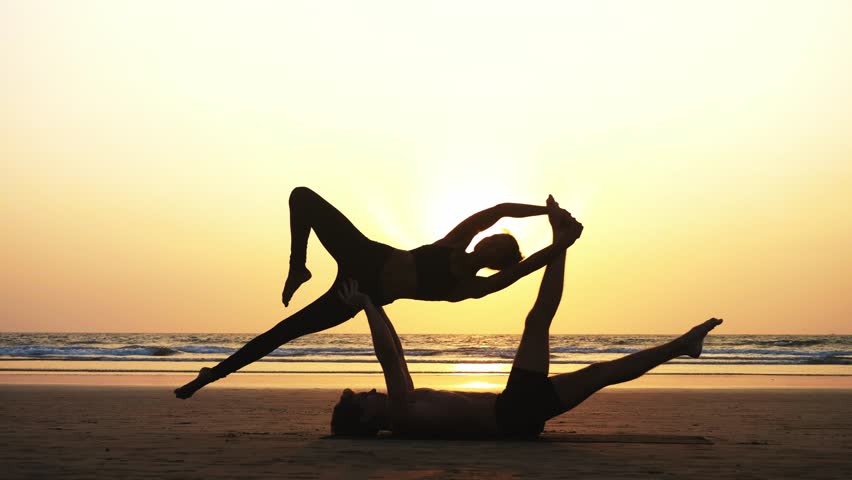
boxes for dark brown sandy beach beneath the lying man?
[0,384,852,479]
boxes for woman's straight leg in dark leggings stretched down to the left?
[175,282,357,398]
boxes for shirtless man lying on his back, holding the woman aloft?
[331,209,722,438]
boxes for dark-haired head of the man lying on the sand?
[331,388,388,436]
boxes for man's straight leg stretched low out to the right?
[550,318,722,412]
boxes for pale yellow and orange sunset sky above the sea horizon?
[0,0,852,334]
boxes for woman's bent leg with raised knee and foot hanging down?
[281,187,370,306]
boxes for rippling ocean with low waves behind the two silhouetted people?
[0,333,852,376]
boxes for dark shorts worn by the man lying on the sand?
[494,368,565,438]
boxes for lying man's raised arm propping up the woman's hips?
[338,280,414,408]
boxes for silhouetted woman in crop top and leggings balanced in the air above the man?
[175,187,573,398]
